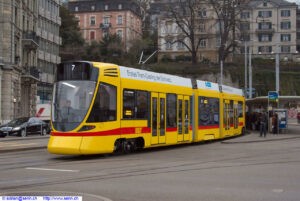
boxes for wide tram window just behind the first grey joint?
[198,96,219,126]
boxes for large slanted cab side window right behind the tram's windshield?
[87,83,117,122]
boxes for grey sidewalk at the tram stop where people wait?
[222,125,300,144]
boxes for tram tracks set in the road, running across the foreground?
[2,142,300,190]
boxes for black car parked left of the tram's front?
[0,117,50,137]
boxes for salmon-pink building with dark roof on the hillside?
[68,0,142,49]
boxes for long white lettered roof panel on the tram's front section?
[119,66,192,88]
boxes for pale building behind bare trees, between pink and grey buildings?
[158,3,219,61]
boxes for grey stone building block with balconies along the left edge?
[0,0,61,123]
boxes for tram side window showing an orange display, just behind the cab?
[123,89,135,119]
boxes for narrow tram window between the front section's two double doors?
[167,94,177,128]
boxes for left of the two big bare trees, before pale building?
[162,0,212,64]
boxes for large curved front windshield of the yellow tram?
[51,64,97,131]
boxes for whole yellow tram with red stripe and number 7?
[48,61,245,154]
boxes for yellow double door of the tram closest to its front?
[151,93,166,145]
